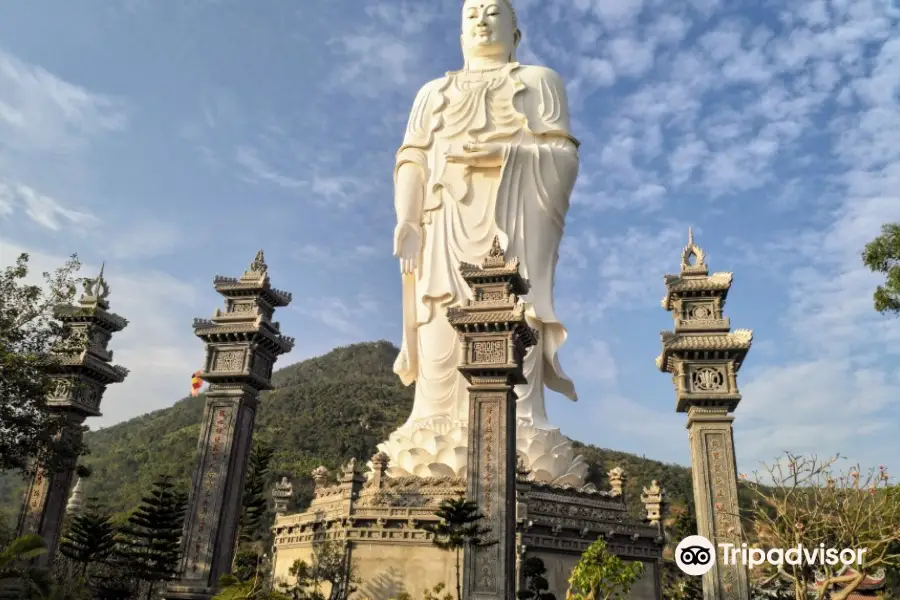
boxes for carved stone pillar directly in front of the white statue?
[447,238,536,600]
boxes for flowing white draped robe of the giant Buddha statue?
[394,62,578,431]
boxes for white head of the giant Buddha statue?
[460,0,522,64]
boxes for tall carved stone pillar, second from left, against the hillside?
[166,251,294,600]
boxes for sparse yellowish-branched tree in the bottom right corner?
[751,452,900,600]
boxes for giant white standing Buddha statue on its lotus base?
[380,0,587,486]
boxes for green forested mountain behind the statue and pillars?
[0,341,708,528]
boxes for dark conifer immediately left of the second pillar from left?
[118,475,187,600]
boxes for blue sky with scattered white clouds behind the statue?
[0,0,900,478]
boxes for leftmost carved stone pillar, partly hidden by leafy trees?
[18,268,128,566]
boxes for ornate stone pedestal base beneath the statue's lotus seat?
[273,473,663,600]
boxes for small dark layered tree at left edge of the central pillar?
[423,498,497,600]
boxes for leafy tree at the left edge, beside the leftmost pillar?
[0,254,84,473]
